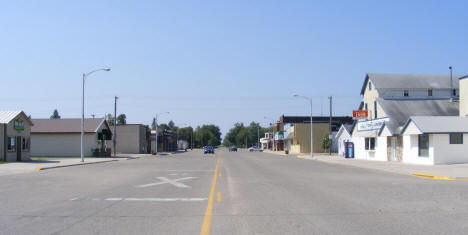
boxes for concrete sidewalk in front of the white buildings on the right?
[264,150,468,180]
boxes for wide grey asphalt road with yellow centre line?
[0,150,468,235]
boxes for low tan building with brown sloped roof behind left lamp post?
[31,118,112,157]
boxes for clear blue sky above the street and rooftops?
[0,1,468,133]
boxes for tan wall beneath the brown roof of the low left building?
[31,133,98,157]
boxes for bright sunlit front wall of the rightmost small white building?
[402,135,434,165]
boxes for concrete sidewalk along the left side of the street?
[0,154,143,176]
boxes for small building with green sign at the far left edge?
[0,111,33,161]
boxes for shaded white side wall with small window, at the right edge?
[431,134,468,164]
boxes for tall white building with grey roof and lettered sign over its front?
[351,74,459,162]
